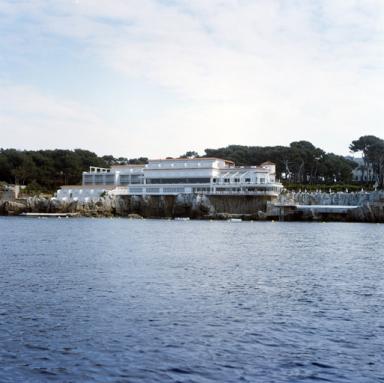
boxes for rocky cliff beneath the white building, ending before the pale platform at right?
[0,194,276,218]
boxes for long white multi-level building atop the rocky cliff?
[57,158,283,201]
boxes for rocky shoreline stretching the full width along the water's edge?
[0,191,384,223]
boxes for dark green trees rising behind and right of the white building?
[182,135,384,188]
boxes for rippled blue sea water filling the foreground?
[0,218,384,383]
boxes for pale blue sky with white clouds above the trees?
[0,0,384,158]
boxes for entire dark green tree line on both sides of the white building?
[0,136,384,192]
